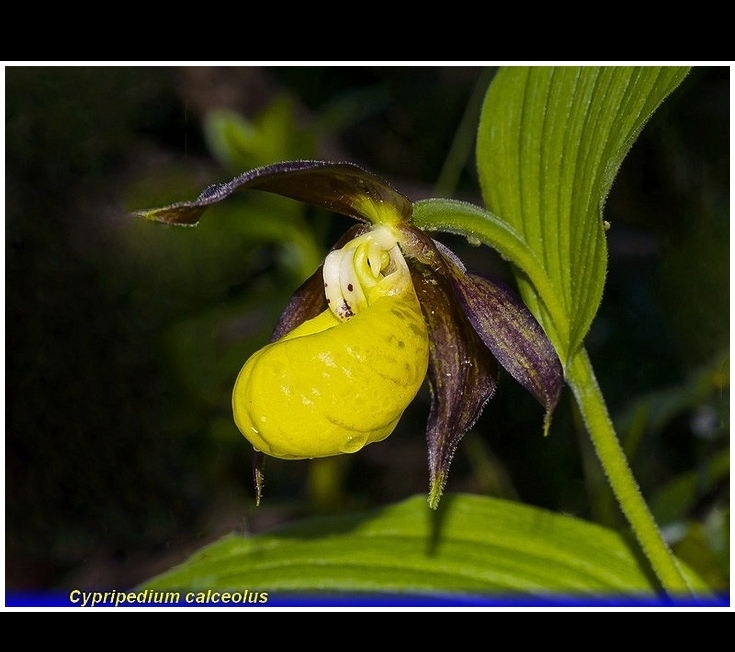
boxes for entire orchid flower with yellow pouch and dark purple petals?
[136,161,563,507]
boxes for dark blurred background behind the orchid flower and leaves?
[5,66,730,591]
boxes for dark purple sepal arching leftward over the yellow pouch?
[134,161,412,225]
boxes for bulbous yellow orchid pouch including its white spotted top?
[232,226,429,459]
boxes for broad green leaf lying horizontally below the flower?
[142,495,701,598]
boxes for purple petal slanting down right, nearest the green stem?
[442,255,564,432]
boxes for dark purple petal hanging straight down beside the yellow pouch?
[411,268,498,509]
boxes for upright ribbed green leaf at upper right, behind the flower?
[477,66,688,365]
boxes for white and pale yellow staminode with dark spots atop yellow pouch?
[322,226,410,321]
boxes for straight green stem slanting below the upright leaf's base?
[566,348,693,595]
